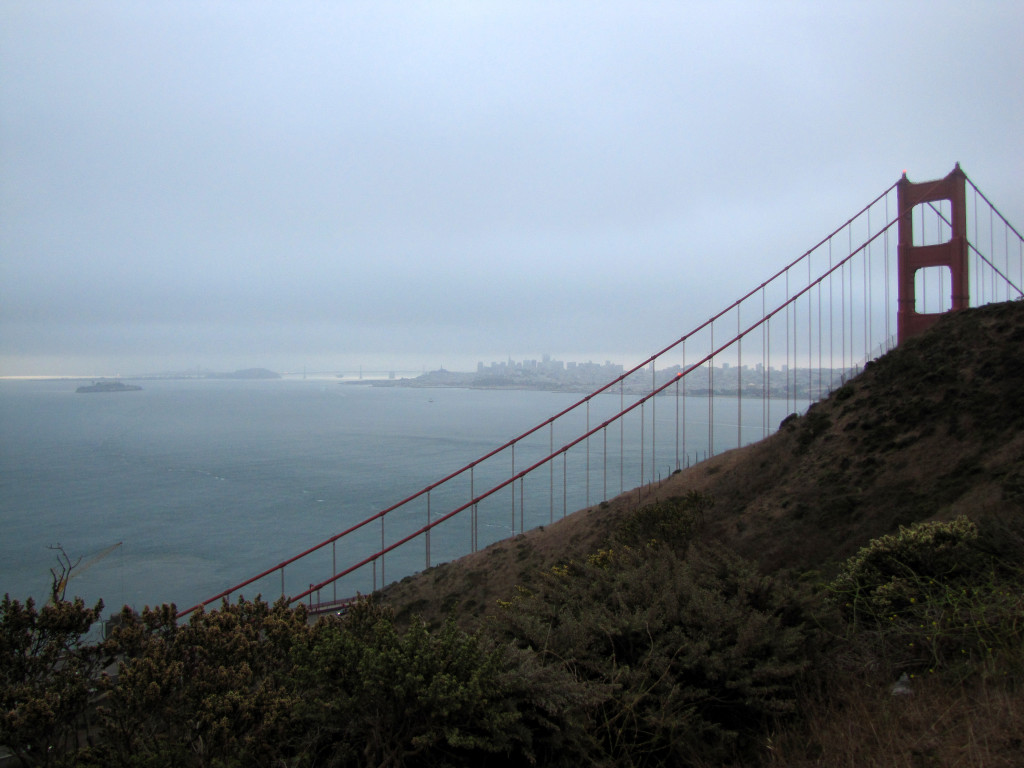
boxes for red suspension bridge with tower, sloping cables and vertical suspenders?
[178,164,1024,616]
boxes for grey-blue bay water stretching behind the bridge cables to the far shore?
[0,379,786,609]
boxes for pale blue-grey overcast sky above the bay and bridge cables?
[0,0,1024,376]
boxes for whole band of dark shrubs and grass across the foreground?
[0,494,1024,766]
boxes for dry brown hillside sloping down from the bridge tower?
[382,301,1024,626]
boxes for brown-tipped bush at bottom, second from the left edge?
[93,598,308,766]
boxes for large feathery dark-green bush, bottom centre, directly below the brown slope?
[504,546,811,766]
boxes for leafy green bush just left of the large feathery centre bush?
[297,601,588,766]
